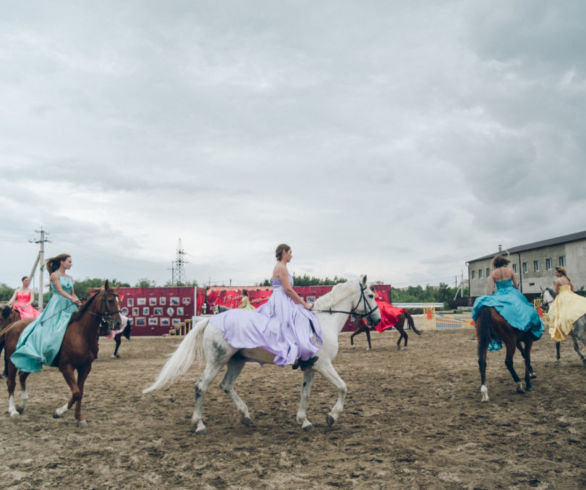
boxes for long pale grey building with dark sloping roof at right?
[466,231,586,297]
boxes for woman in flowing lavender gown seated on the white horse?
[210,243,321,369]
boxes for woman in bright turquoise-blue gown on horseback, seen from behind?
[472,255,543,351]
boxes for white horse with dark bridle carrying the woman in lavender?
[143,276,381,434]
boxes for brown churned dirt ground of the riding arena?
[0,320,586,489]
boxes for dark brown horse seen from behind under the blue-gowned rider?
[476,306,535,402]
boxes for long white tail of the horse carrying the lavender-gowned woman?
[142,319,208,393]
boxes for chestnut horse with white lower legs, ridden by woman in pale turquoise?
[3,281,120,427]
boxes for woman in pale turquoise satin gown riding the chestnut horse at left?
[10,254,81,373]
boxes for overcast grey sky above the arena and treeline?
[0,0,586,287]
